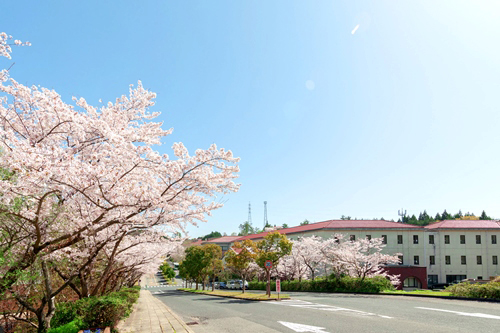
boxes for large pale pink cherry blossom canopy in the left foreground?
[0,35,239,293]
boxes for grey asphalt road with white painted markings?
[149,287,500,333]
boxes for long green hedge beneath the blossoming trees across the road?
[248,276,395,294]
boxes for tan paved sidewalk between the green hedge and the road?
[117,290,194,333]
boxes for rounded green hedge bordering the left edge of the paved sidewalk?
[49,287,140,333]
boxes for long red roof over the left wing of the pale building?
[238,220,423,241]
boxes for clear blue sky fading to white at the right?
[0,0,500,236]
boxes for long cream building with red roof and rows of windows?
[210,220,500,288]
